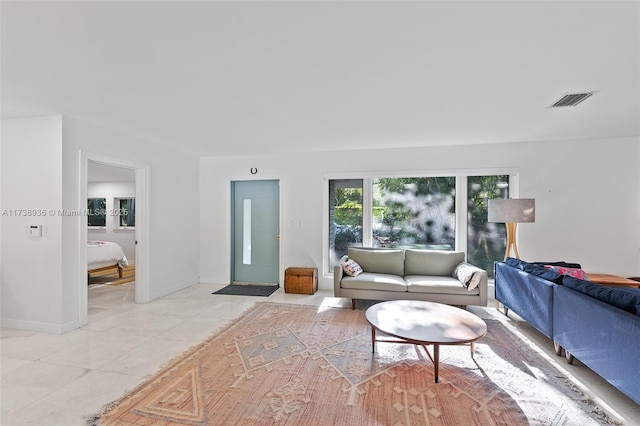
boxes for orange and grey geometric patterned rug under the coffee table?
[90,303,609,426]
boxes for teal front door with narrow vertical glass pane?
[231,180,280,284]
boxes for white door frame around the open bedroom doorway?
[78,151,149,326]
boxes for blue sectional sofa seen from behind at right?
[495,258,640,404]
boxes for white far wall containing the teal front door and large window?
[200,138,640,289]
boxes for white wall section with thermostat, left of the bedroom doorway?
[0,116,62,333]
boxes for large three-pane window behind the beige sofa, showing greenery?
[327,174,509,275]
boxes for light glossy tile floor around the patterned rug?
[0,283,640,426]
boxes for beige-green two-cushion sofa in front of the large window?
[333,247,488,309]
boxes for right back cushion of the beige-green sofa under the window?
[404,249,465,277]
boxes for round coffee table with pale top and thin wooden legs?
[365,300,487,383]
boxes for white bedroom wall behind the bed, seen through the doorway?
[87,182,136,263]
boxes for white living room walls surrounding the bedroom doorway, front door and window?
[0,111,640,332]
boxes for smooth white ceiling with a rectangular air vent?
[0,1,640,155]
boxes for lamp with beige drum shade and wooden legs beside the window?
[488,198,536,260]
